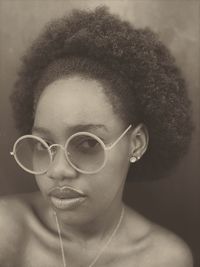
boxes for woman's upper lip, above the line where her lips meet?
[49,186,85,199]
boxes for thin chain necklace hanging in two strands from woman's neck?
[54,207,124,267]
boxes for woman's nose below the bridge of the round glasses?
[47,147,78,180]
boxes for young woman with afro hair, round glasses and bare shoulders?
[0,7,192,267]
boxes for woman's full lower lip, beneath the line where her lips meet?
[50,197,85,210]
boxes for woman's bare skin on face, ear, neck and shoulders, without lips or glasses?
[0,76,192,267]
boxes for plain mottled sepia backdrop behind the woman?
[0,0,200,267]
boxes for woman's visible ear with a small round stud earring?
[130,123,149,162]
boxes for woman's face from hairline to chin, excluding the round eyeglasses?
[32,76,130,226]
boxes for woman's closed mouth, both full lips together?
[49,186,86,210]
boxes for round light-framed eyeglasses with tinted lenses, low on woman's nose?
[10,125,132,175]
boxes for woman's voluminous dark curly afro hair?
[11,7,193,180]
